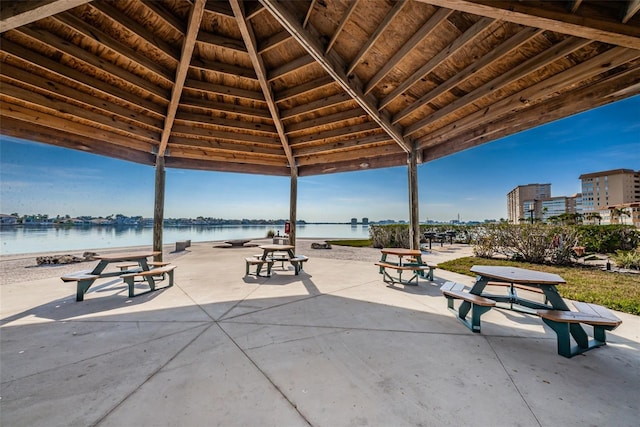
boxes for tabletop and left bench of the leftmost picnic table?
[61,251,160,301]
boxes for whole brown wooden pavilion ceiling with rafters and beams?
[0,0,640,176]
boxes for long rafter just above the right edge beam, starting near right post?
[418,47,640,148]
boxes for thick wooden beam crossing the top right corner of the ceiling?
[418,0,640,50]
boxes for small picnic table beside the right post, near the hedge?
[375,248,436,285]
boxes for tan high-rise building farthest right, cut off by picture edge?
[580,169,640,215]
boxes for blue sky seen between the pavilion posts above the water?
[0,96,640,222]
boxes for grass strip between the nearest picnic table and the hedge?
[438,257,640,315]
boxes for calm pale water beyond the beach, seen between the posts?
[0,224,369,255]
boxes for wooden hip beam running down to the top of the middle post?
[230,0,297,171]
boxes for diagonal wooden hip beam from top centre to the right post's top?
[260,0,411,152]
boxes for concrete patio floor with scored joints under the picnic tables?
[0,243,640,427]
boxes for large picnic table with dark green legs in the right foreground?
[441,265,622,357]
